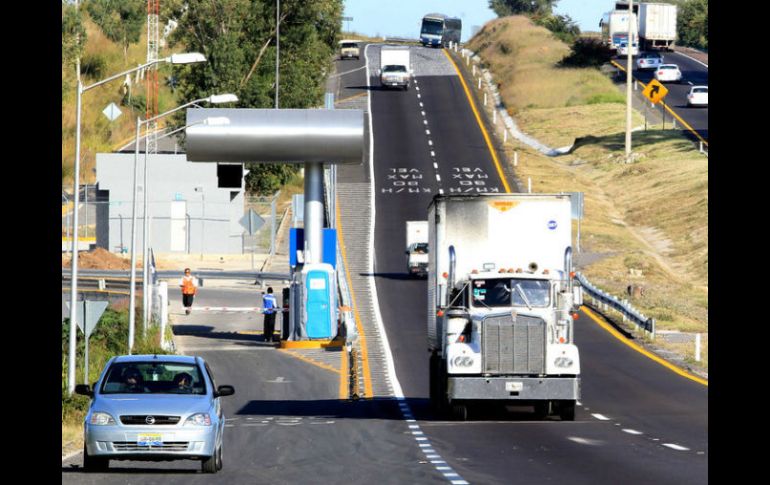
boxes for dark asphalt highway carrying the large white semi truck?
[368,46,708,484]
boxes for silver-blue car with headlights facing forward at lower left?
[75,355,235,473]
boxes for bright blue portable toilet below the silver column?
[302,263,337,340]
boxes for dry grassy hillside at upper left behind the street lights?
[61,15,176,185]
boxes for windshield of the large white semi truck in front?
[472,278,551,308]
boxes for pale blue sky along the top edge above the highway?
[342,0,614,42]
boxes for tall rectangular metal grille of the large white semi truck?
[482,314,545,374]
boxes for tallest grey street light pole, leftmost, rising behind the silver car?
[67,52,206,395]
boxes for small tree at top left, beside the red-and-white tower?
[87,0,147,61]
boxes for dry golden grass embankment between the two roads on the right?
[468,17,708,369]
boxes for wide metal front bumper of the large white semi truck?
[447,376,580,401]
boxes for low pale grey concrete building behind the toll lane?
[96,152,247,254]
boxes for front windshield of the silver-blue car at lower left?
[101,361,206,394]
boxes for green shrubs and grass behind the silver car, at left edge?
[61,304,170,454]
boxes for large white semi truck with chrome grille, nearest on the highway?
[428,194,582,421]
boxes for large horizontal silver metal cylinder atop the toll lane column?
[185,108,364,164]
